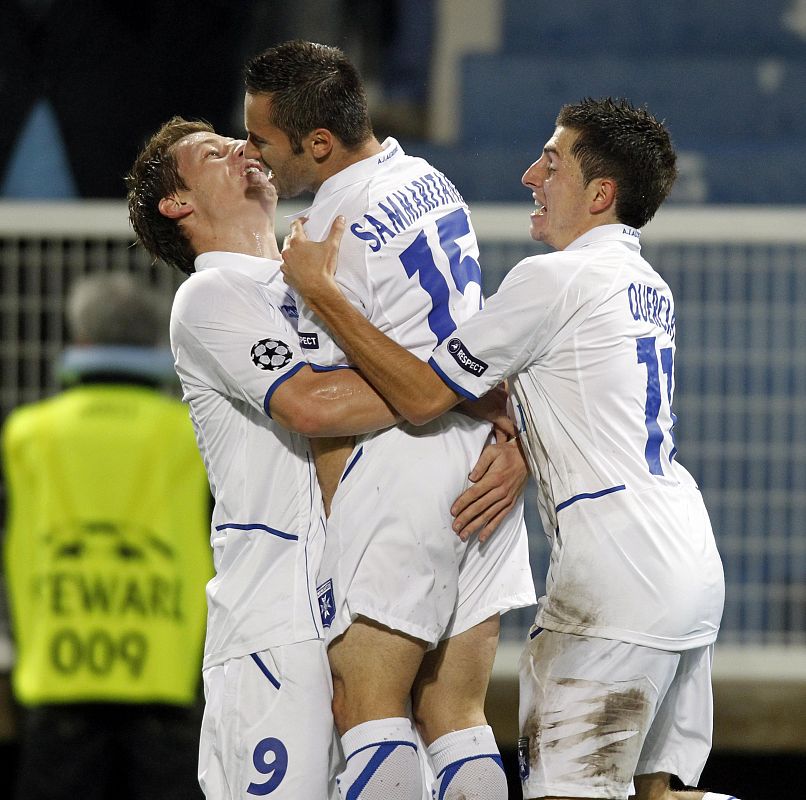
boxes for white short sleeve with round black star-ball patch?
[171,270,306,414]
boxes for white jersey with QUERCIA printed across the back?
[431,225,724,650]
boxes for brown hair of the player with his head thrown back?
[125,117,215,275]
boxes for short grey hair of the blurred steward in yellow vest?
[66,272,168,347]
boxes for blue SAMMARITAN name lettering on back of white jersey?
[350,171,465,253]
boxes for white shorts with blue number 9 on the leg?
[204,639,341,800]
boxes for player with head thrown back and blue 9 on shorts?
[127,118,522,800]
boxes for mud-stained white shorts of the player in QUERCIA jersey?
[518,628,713,799]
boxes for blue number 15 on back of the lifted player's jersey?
[400,208,481,344]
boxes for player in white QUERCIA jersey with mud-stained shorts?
[283,98,740,800]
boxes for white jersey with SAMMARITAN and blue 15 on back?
[299,139,481,368]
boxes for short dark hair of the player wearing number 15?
[244,39,373,153]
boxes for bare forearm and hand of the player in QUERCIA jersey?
[283,212,462,425]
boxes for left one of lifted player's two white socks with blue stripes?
[336,717,423,800]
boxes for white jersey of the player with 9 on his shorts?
[171,253,324,668]
